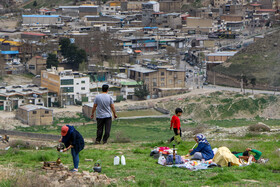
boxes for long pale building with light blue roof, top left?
[22,15,62,25]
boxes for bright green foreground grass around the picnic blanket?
[0,135,280,186]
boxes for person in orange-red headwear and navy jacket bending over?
[59,125,85,172]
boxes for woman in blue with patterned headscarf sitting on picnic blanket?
[186,134,214,160]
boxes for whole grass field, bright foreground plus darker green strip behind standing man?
[8,118,280,186]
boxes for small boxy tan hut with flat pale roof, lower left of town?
[16,105,53,125]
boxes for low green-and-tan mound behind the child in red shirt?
[157,92,280,121]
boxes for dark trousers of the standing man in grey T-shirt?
[96,118,112,142]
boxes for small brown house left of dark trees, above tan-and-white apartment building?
[26,56,47,75]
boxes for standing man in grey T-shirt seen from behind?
[91,84,117,144]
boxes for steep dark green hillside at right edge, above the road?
[214,32,280,88]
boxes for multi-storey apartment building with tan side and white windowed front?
[41,67,90,106]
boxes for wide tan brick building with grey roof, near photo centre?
[128,64,185,97]
